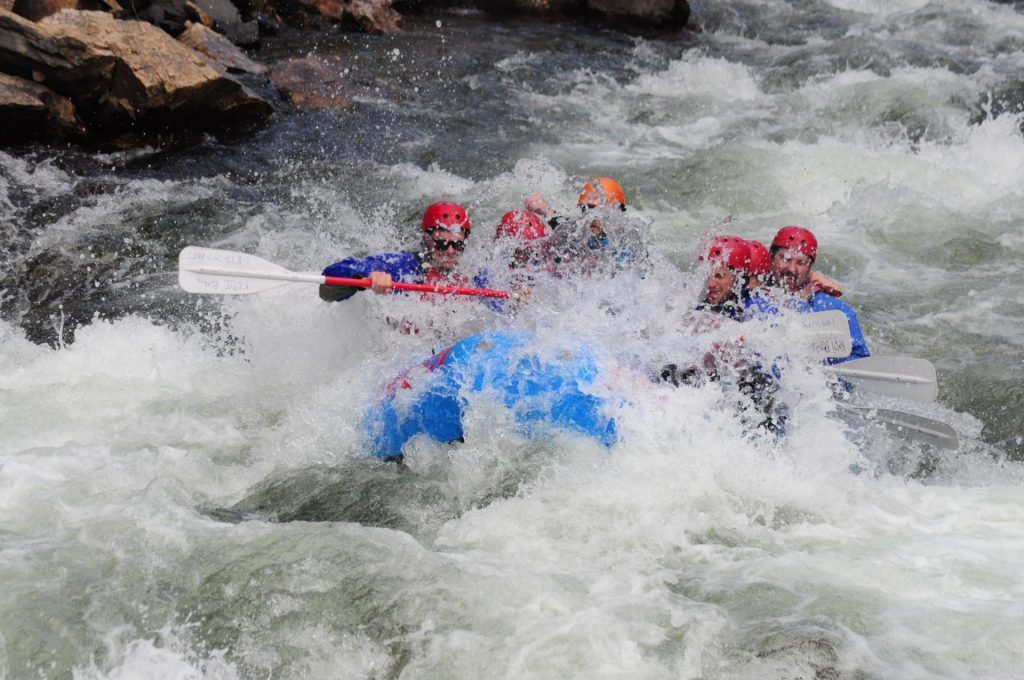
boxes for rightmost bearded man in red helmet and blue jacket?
[746,226,870,364]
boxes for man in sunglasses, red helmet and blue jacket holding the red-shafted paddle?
[319,201,472,302]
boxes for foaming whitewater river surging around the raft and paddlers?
[0,0,1024,680]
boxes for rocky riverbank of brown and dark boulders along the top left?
[0,0,689,147]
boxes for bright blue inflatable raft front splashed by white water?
[364,333,616,460]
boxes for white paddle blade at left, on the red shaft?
[178,246,323,295]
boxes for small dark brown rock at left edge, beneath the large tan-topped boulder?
[0,73,85,140]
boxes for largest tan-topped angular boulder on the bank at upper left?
[0,10,273,144]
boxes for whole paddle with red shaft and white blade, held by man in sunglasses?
[178,246,509,298]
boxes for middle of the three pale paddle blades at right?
[828,356,939,401]
